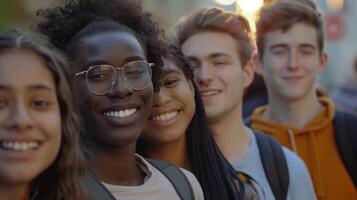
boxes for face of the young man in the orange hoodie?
[257,22,327,101]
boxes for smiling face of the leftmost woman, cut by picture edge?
[0,50,61,185]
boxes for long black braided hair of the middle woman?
[137,45,245,200]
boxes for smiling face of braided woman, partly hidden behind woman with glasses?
[143,60,195,143]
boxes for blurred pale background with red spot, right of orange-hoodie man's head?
[317,0,357,87]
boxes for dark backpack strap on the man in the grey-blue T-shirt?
[255,132,289,200]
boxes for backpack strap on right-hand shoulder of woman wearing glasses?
[146,159,194,200]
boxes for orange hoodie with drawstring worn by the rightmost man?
[251,97,357,200]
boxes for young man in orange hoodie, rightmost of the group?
[250,0,357,200]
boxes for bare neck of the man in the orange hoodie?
[262,91,324,129]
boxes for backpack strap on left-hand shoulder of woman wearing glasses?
[81,172,115,200]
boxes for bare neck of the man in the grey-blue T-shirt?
[209,104,251,162]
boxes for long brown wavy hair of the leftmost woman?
[0,28,87,200]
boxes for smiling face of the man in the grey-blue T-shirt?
[181,32,252,122]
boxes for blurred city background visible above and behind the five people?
[0,0,357,88]
